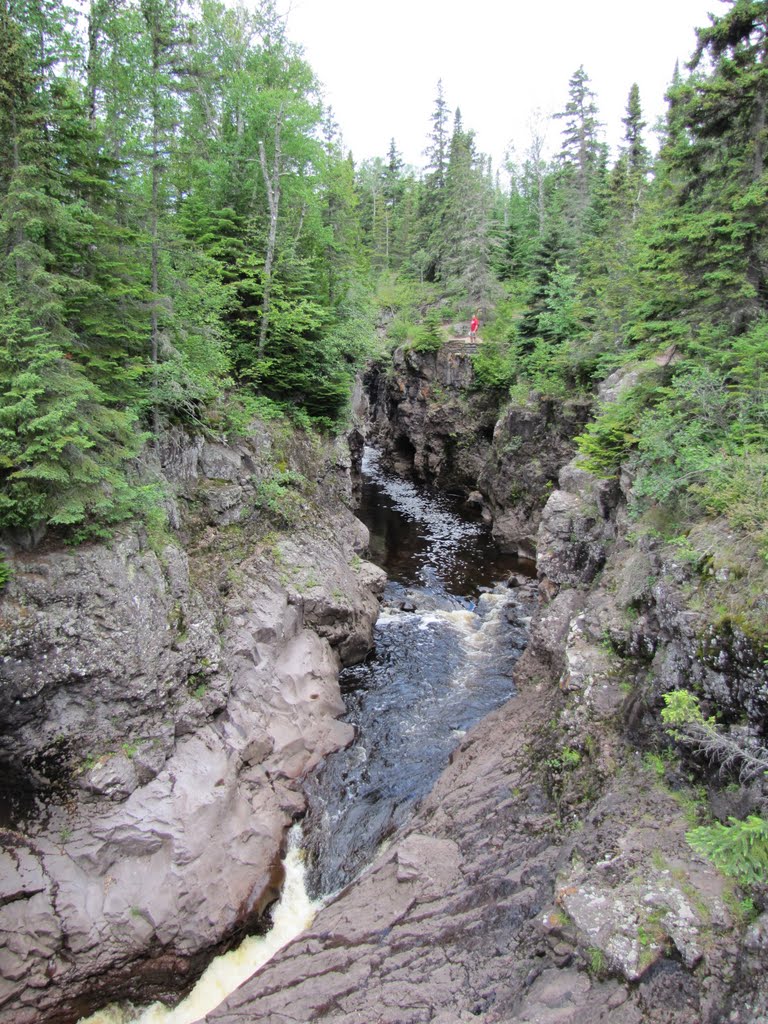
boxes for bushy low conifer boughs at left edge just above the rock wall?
[0,292,159,539]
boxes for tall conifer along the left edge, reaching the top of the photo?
[0,0,148,536]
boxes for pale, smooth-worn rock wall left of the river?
[0,419,384,1024]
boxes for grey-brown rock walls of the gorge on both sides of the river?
[1,349,768,1024]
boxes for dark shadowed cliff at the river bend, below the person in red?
[369,350,592,558]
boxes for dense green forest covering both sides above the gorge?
[0,0,768,581]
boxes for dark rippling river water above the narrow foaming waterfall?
[304,451,536,896]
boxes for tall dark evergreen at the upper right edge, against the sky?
[654,0,768,332]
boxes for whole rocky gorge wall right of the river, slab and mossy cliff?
[199,354,768,1024]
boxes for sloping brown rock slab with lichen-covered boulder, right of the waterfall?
[207,622,745,1024]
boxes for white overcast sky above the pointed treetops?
[270,0,727,169]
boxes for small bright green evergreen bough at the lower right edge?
[685,814,768,886]
